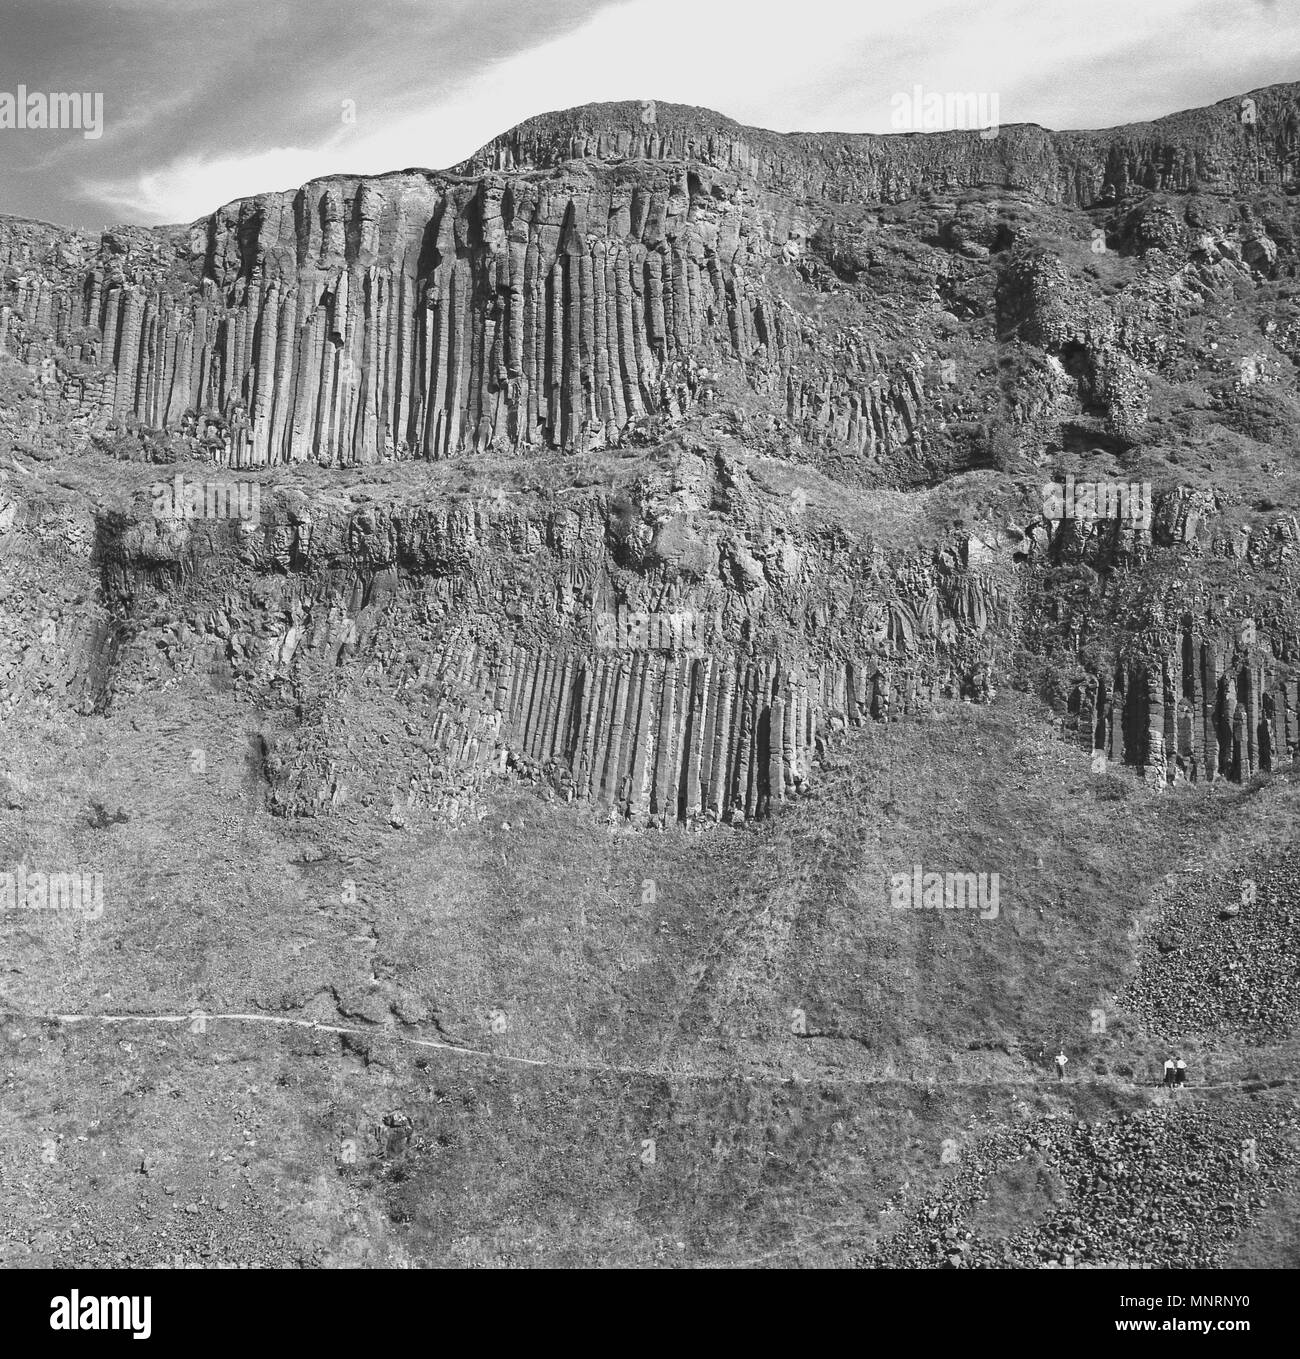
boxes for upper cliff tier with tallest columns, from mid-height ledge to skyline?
[0,84,1300,480]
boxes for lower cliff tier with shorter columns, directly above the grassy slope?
[0,440,1300,825]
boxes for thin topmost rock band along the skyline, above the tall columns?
[456,84,1300,208]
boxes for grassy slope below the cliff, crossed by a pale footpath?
[0,674,1296,1264]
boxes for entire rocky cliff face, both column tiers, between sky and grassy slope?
[0,86,1300,824]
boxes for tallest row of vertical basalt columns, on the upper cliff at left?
[0,167,921,467]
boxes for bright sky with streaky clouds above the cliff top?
[0,0,1300,227]
